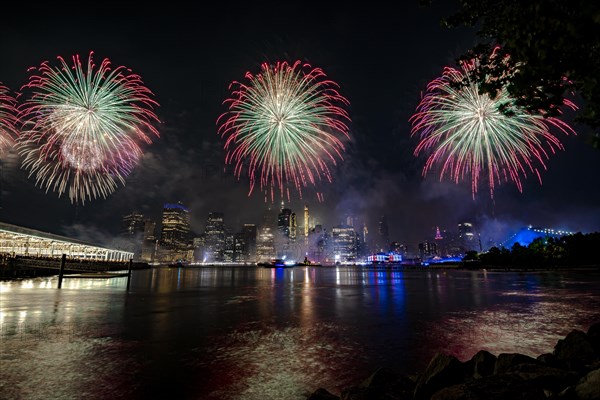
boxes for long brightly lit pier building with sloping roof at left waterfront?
[0,222,133,262]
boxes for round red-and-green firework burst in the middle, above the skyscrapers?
[217,61,350,201]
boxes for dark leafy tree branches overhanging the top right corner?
[428,0,600,130]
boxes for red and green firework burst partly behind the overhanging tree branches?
[410,51,577,198]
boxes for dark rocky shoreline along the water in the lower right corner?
[308,322,600,400]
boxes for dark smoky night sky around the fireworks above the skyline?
[0,5,600,248]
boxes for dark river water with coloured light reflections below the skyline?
[0,266,600,400]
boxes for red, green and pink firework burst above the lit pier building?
[17,52,160,203]
